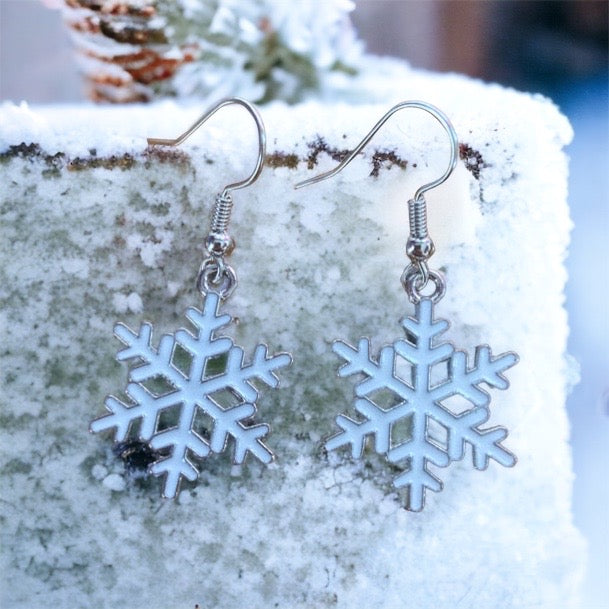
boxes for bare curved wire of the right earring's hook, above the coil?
[294,100,459,201]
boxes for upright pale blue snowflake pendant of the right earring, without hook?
[325,298,518,511]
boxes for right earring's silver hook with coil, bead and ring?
[294,100,459,302]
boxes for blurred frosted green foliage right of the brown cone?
[164,0,363,102]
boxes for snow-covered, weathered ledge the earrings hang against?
[0,64,584,609]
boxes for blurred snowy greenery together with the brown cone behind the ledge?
[55,0,362,102]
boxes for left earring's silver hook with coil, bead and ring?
[148,97,266,299]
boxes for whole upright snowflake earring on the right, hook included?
[296,101,518,511]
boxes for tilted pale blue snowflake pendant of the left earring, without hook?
[91,292,292,498]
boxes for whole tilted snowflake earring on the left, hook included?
[90,98,292,498]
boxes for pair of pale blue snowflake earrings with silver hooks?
[90,98,518,511]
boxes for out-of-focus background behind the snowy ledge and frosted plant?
[0,0,609,609]
